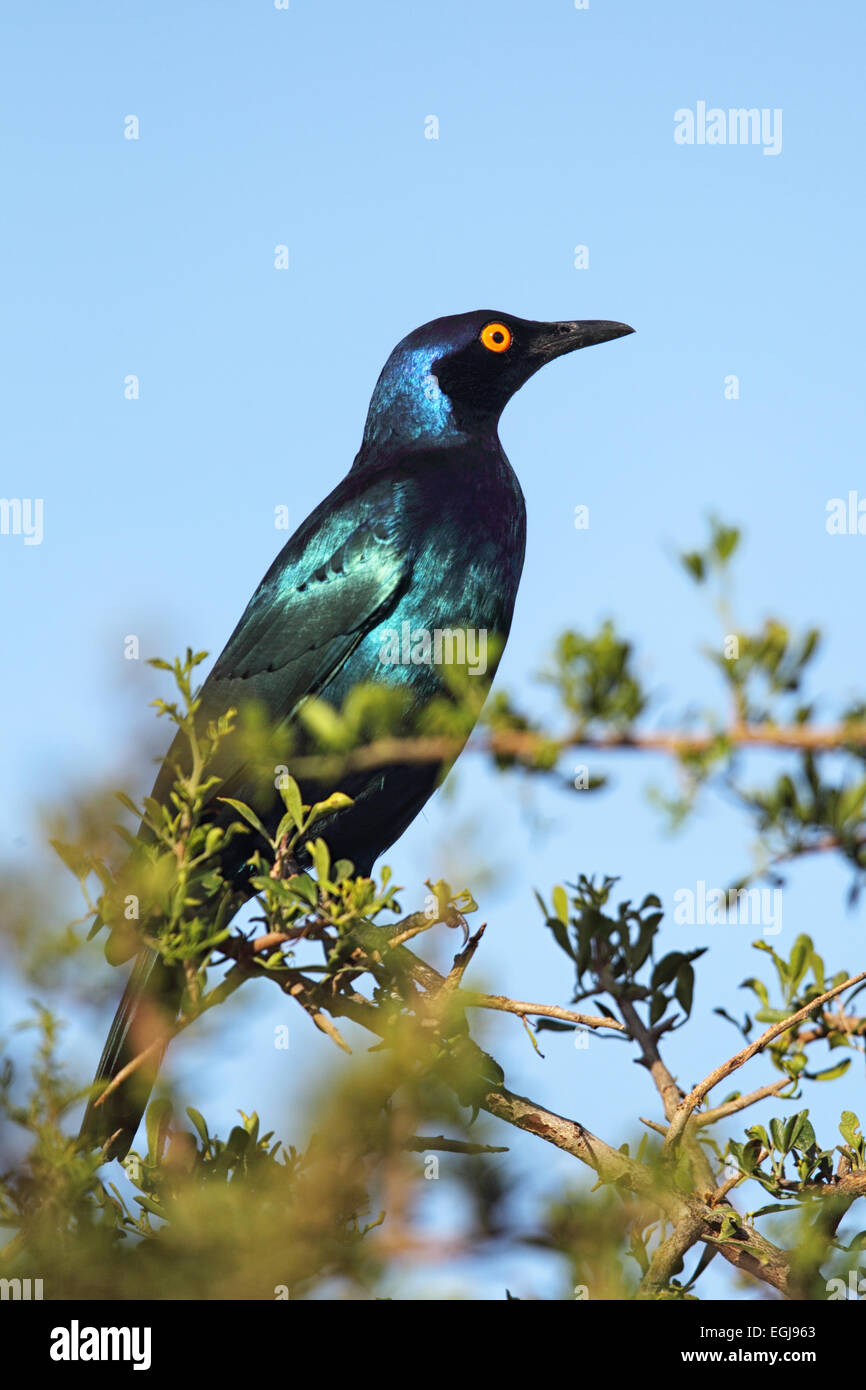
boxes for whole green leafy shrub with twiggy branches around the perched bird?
[0,518,866,1300]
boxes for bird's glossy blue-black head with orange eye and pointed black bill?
[359,309,634,460]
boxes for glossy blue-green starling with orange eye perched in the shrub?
[82,310,632,1156]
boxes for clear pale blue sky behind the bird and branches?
[0,0,866,1297]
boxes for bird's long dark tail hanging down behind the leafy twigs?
[81,947,183,1158]
